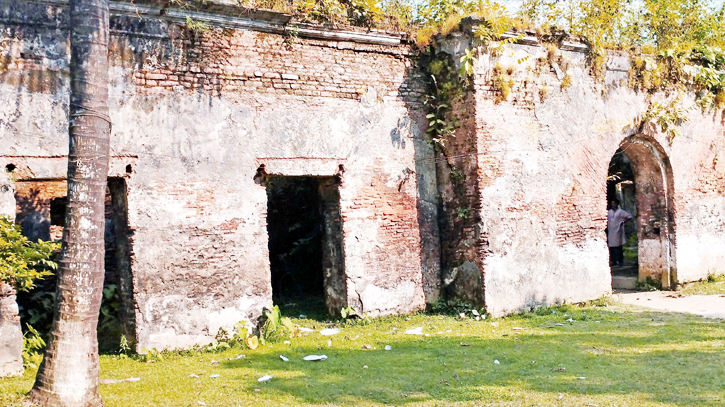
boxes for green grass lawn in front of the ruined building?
[0,305,725,406]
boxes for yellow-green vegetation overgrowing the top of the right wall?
[416,0,725,145]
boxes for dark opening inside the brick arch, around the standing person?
[607,148,639,288]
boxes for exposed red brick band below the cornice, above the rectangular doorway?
[121,25,422,104]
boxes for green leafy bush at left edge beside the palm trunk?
[0,217,60,291]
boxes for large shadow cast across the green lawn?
[224,313,725,405]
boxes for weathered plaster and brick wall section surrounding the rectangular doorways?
[0,2,439,349]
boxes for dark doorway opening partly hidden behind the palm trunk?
[16,177,135,352]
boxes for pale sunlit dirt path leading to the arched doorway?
[615,291,725,319]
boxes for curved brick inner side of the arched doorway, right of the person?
[619,134,677,288]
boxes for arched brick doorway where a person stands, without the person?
[607,135,677,288]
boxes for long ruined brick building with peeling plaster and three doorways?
[0,0,725,349]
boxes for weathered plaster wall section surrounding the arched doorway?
[439,21,725,315]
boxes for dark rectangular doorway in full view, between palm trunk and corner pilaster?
[264,176,347,314]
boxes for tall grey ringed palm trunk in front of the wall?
[30,0,111,407]
